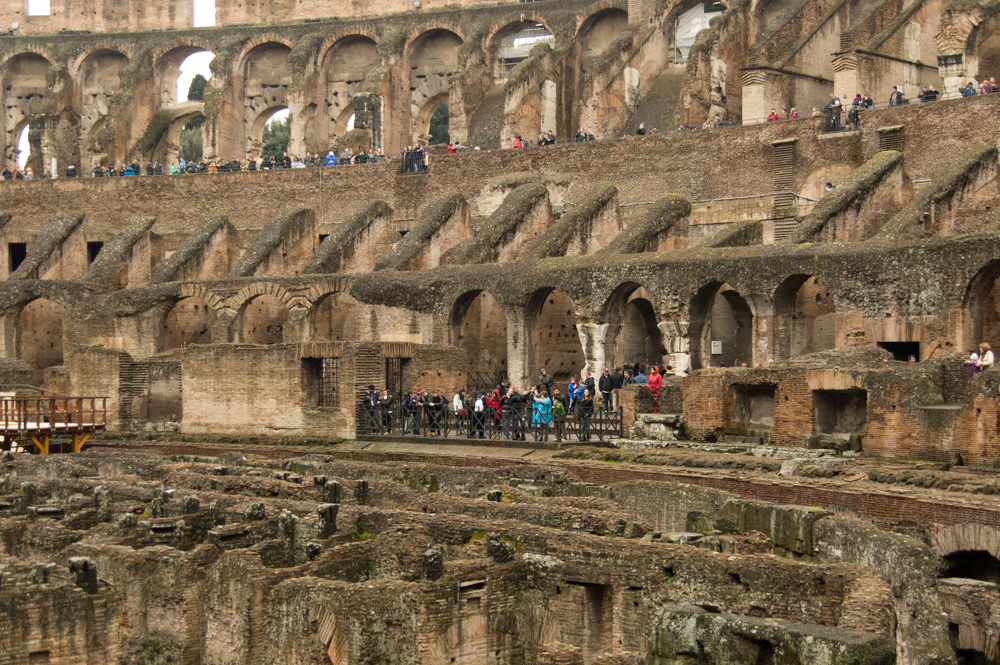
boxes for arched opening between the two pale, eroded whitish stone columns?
[605,283,667,367]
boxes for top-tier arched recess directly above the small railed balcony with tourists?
[408,29,462,143]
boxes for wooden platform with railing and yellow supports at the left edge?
[0,394,108,455]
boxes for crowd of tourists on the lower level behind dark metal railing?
[362,363,673,441]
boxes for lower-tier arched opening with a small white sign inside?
[688,282,753,369]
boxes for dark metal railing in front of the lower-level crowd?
[358,400,624,443]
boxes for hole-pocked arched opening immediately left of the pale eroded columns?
[525,289,586,383]
